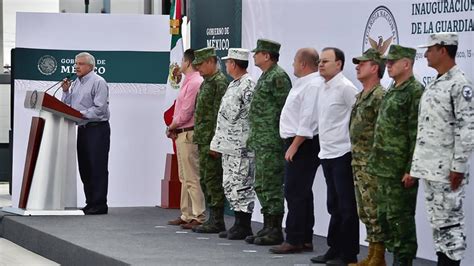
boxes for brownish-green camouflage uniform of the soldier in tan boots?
[349,84,384,242]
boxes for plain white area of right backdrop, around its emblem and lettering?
[242,0,474,265]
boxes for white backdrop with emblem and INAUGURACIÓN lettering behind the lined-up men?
[243,0,474,265]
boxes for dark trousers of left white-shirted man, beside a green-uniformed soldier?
[284,135,320,245]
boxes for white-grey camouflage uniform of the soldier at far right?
[411,41,474,260]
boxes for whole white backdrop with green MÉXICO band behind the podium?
[12,13,171,207]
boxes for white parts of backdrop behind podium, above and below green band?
[12,13,171,207]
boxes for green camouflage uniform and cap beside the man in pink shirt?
[193,48,229,233]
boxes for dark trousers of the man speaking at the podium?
[77,122,110,206]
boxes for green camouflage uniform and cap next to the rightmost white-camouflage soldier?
[367,45,423,265]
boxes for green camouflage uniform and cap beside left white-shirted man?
[247,39,291,244]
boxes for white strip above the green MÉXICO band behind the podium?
[16,13,170,51]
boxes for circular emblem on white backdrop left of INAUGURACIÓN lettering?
[362,6,399,55]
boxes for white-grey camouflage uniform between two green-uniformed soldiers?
[211,74,255,213]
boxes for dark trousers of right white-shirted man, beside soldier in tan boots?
[321,152,359,259]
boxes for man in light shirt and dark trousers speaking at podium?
[62,52,110,215]
